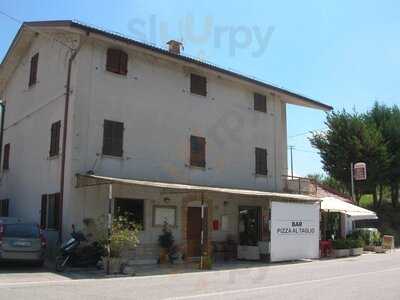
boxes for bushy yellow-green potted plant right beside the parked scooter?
[103,217,139,274]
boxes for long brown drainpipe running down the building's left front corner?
[58,49,79,243]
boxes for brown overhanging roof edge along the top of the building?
[0,20,333,111]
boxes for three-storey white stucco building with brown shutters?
[0,21,331,258]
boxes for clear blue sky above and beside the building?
[0,0,400,176]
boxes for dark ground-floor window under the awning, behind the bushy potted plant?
[114,198,144,229]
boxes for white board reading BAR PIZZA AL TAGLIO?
[271,201,320,262]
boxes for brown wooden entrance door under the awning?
[186,207,207,257]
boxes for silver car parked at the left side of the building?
[0,223,46,266]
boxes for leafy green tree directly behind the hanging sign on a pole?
[310,110,388,203]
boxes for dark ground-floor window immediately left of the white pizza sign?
[239,206,261,246]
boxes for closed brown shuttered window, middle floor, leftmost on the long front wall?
[103,120,124,156]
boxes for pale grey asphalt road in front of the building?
[0,251,400,300]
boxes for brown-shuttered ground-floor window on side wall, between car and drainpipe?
[40,193,61,230]
